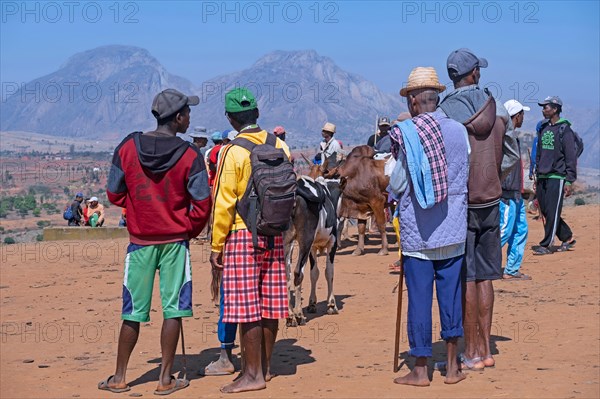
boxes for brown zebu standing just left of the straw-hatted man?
[324,145,390,255]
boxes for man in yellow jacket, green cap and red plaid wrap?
[210,88,290,393]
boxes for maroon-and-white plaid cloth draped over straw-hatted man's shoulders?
[389,113,448,204]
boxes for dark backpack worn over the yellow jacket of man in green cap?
[231,133,297,249]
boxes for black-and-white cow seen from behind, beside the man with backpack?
[284,176,341,326]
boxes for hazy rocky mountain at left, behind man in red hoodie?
[0,45,194,138]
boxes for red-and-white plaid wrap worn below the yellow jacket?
[222,229,288,323]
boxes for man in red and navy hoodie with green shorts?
[98,89,211,395]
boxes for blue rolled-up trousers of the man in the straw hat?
[404,255,464,357]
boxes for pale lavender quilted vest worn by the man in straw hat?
[398,112,469,252]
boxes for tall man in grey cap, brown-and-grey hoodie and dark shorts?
[439,48,520,370]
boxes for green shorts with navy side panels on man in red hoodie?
[121,241,193,322]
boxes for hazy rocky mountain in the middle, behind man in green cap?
[192,51,406,146]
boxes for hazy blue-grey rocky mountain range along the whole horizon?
[0,45,600,168]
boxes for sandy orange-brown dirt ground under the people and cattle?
[0,205,600,398]
